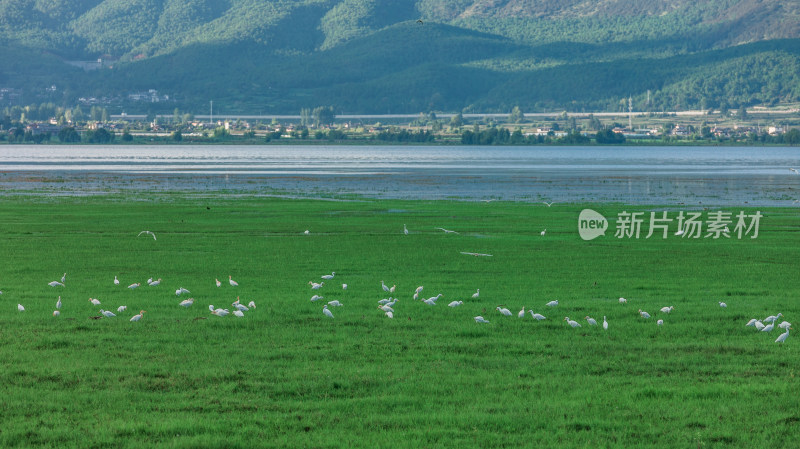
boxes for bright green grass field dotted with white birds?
[0,193,800,448]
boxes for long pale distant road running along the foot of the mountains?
[111,109,798,122]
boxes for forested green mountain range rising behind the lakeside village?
[0,0,800,114]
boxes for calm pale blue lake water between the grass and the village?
[0,145,800,206]
